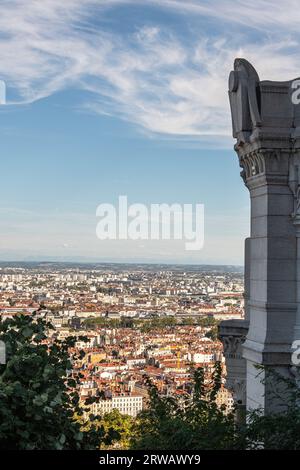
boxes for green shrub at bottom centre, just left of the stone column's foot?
[131,364,235,450]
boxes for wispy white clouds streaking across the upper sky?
[0,0,300,140]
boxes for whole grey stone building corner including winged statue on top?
[220,59,300,413]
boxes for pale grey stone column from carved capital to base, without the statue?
[240,149,297,411]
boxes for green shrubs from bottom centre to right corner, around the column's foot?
[130,364,300,450]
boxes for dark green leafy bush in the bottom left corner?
[0,315,111,449]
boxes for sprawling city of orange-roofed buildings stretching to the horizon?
[0,263,244,432]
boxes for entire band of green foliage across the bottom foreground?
[0,315,300,450]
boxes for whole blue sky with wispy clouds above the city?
[0,0,300,264]
